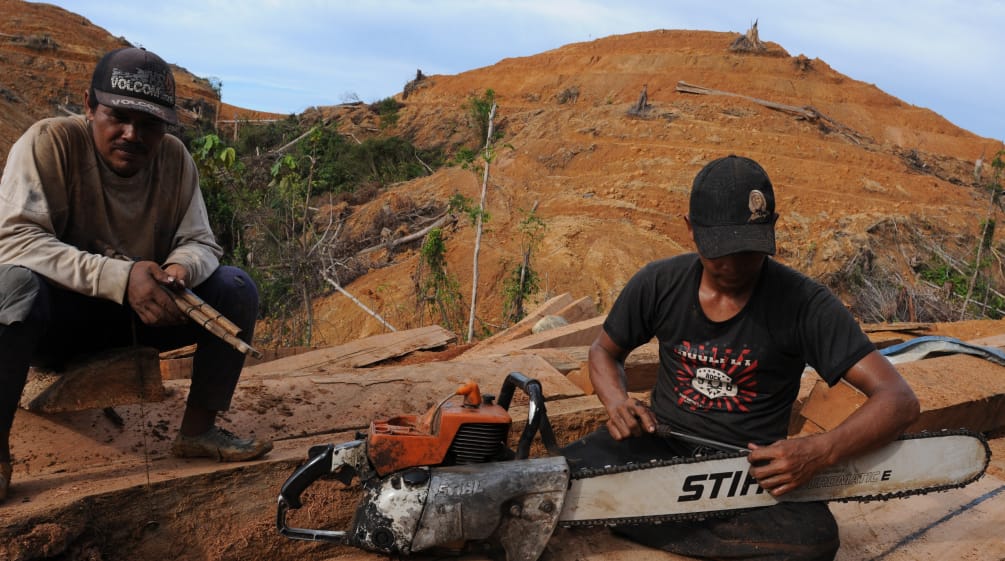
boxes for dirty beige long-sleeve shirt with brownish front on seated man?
[0,117,223,304]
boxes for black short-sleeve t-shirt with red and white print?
[604,253,875,445]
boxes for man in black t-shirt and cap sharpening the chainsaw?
[564,156,919,560]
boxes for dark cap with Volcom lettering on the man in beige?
[90,47,178,125]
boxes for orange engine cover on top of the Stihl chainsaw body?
[367,382,513,477]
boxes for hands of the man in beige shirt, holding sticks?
[126,261,188,326]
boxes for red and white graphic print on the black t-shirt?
[673,341,757,411]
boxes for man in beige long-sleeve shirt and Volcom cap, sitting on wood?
[0,47,272,501]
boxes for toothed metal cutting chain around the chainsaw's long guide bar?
[559,428,991,528]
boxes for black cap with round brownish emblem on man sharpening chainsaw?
[688,155,778,259]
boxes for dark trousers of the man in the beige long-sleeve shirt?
[0,265,258,432]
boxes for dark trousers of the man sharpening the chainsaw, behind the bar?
[562,428,840,561]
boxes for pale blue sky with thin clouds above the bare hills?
[50,0,1005,140]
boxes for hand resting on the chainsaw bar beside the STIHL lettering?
[747,436,831,497]
